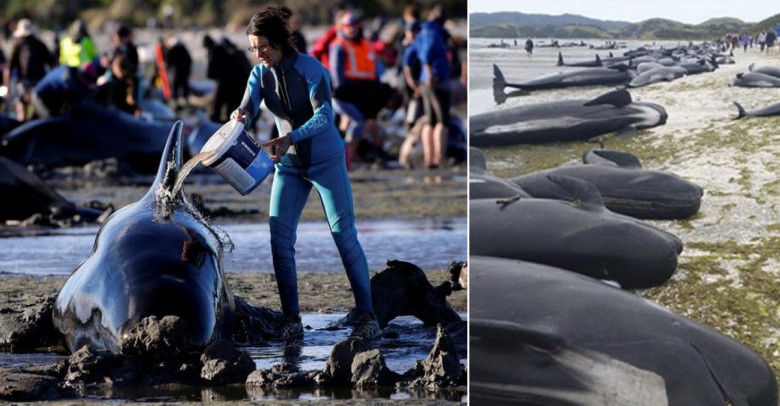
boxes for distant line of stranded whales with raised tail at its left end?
[493,44,734,104]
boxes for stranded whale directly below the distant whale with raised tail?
[469,89,668,147]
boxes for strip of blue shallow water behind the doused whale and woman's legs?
[0,219,467,276]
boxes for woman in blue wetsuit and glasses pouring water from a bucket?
[230,7,381,339]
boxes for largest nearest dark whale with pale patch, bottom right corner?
[469,256,778,405]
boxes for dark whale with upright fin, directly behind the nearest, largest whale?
[469,176,683,289]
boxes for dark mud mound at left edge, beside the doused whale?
[0,297,61,352]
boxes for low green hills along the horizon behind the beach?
[469,12,780,40]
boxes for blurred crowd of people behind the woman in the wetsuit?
[0,6,466,168]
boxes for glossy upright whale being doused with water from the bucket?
[53,121,235,353]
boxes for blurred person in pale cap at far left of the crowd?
[3,18,57,121]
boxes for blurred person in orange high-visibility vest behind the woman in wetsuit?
[330,12,393,168]
